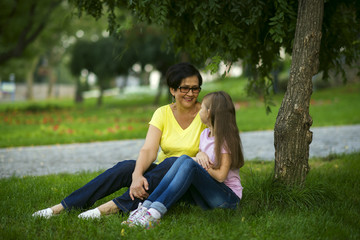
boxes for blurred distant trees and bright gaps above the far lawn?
[0,0,359,105]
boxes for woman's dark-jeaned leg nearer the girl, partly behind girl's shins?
[112,157,177,213]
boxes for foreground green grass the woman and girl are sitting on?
[0,153,360,239]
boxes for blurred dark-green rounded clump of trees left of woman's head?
[70,25,176,105]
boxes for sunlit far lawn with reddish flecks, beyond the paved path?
[0,78,360,148]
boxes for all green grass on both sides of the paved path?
[0,79,360,239]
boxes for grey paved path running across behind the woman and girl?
[0,125,360,178]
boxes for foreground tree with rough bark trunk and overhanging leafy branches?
[72,0,360,185]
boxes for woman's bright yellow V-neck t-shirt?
[149,105,206,163]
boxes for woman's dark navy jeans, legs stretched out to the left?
[61,157,177,212]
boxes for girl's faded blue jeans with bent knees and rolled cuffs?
[143,155,240,215]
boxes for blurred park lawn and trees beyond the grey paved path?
[0,0,360,148]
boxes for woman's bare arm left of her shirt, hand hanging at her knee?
[129,125,162,200]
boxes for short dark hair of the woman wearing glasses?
[166,62,202,89]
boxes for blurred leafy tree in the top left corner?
[0,0,68,99]
